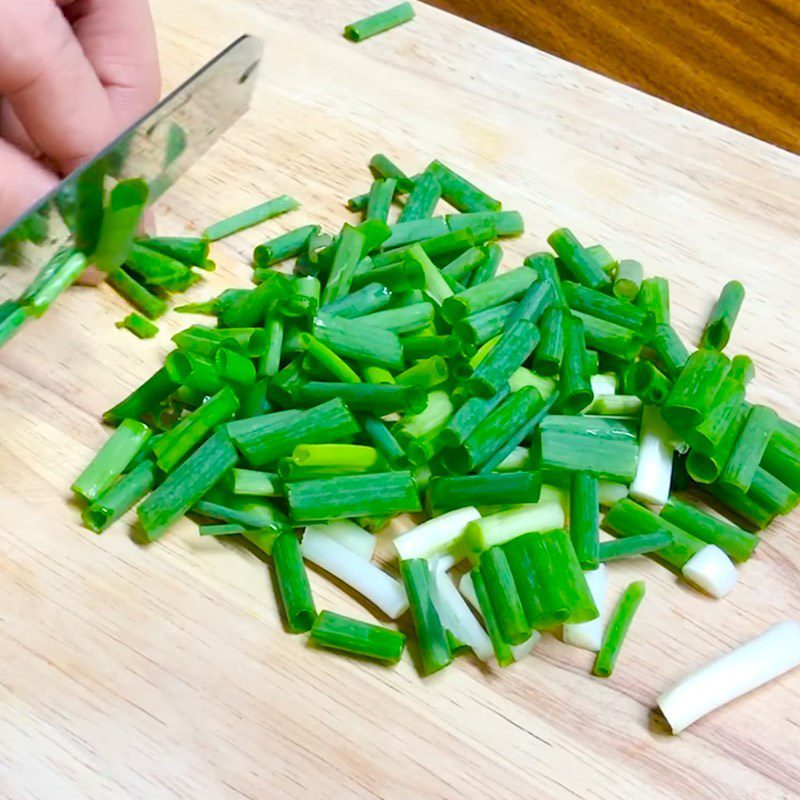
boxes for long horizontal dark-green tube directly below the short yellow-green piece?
[286,472,421,522]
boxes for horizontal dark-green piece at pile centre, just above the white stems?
[427,472,542,512]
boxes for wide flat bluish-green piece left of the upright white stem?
[539,415,639,483]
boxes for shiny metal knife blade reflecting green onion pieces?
[0,36,264,346]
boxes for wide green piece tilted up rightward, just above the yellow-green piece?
[228,400,358,467]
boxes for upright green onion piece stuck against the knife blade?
[91,179,150,272]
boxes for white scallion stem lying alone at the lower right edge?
[657,621,800,733]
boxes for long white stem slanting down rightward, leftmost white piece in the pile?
[300,529,408,619]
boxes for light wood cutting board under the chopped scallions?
[0,0,800,800]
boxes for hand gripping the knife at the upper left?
[0,0,161,228]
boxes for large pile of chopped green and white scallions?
[73,155,800,724]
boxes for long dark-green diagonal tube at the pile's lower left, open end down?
[137,433,237,541]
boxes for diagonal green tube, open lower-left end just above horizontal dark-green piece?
[443,386,545,474]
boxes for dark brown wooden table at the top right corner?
[429,0,800,152]
